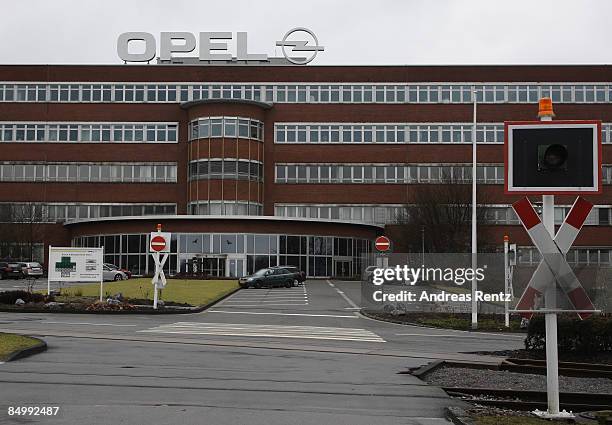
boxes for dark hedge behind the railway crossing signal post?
[525,315,612,353]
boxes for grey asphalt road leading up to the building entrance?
[0,281,522,425]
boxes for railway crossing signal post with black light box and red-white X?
[504,98,602,419]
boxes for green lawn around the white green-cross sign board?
[57,278,238,306]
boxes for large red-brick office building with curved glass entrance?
[0,64,612,276]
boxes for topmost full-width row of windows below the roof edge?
[0,82,612,103]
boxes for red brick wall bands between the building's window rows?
[0,65,612,246]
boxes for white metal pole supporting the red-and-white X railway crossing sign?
[541,111,559,415]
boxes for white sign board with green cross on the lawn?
[48,246,104,282]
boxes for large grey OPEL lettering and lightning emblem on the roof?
[117,27,325,65]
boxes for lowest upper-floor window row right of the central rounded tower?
[274,204,612,226]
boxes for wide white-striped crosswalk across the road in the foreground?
[139,322,385,342]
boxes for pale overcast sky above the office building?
[0,0,612,65]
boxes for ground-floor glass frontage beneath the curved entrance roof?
[73,233,371,277]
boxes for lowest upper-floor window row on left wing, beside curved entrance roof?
[0,203,176,223]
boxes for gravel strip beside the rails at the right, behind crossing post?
[425,367,612,394]
